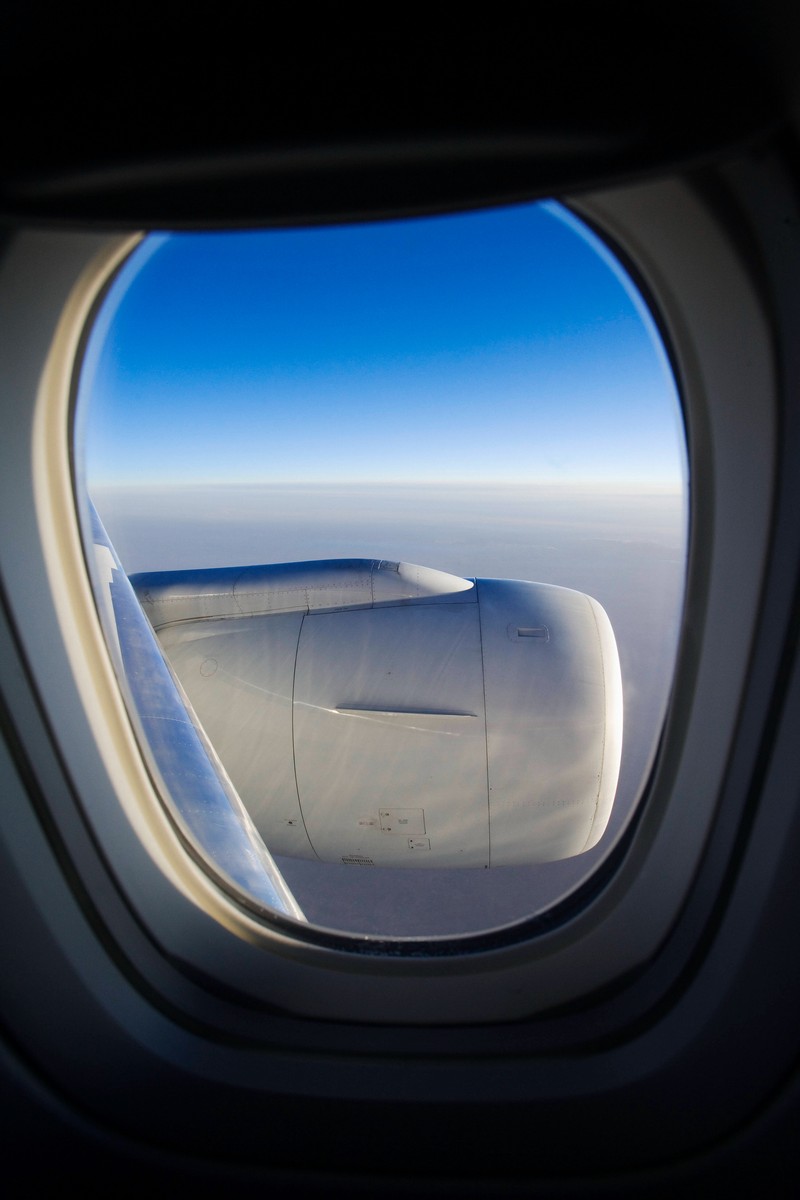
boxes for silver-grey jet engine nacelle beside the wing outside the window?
[131,559,622,868]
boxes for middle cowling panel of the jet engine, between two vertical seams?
[294,604,488,866]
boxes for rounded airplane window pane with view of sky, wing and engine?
[76,202,687,937]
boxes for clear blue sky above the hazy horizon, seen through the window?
[80,204,684,487]
